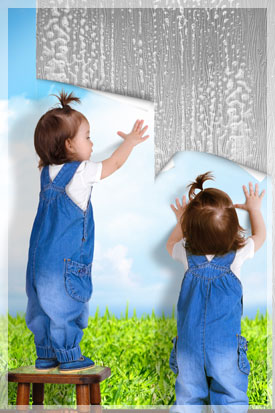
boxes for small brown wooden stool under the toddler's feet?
[7,366,111,406]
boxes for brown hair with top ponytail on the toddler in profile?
[34,90,87,169]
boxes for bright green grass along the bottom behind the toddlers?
[0,308,272,408]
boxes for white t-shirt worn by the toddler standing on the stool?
[41,160,102,211]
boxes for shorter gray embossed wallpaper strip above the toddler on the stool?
[37,8,154,100]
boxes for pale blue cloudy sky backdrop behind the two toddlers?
[5,9,271,317]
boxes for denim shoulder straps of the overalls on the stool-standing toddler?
[40,161,81,190]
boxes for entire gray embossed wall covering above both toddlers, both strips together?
[37,7,267,174]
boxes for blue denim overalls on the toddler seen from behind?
[170,249,250,413]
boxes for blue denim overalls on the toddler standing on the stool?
[26,161,94,362]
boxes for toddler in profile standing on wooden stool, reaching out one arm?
[26,91,149,372]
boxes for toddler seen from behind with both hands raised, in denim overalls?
[167,172,266,413]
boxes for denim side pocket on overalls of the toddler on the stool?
[64,259,93,303]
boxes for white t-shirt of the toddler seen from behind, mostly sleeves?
[172,237,254,278]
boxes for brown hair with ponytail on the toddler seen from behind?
[181,172,245,255]
